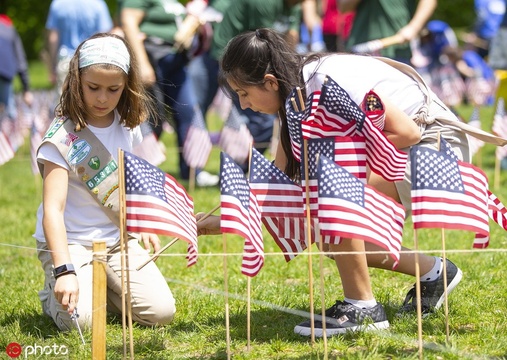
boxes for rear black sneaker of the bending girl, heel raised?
[398,260,463,317]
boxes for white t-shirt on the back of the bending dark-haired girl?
[303,54,425,116]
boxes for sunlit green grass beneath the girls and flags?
[0,90,507,360]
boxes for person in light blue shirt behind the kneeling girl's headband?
[46,0,113,94]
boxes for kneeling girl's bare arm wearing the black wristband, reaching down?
[42,162,79,314]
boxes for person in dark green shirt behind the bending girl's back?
[338,0,437,64]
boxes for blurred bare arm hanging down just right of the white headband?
[121,8,156,85]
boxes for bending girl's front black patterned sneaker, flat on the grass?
[294,301,389,337]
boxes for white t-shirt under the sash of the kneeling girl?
[34,111,142,246]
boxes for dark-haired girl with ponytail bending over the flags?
[196,29,470,336]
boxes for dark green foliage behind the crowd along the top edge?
[0,0,475,60]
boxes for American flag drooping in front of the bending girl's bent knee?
[318,156,405,267]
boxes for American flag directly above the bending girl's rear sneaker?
[410,139,489,236]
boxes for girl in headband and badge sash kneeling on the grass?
[34,33,176,331]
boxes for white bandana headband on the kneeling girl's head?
[79,37,130,74]
